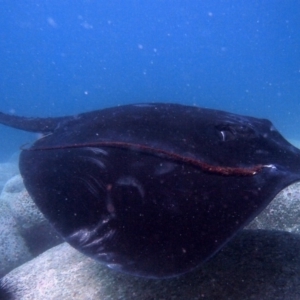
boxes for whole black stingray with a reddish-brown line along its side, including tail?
[0,103,300,278]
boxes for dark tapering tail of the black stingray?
[0,112,74,133]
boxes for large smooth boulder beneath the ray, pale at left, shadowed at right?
[2,230,300,300]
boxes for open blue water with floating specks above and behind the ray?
[0,0,300,161]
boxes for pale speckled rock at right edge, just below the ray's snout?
[247,182,300,233]
